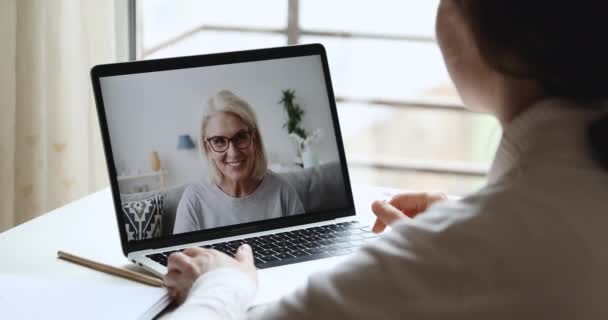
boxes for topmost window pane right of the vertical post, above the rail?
[300,0,439,37]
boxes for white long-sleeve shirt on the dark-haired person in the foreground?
[167,100,608,319]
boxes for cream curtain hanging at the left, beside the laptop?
[0,0,116,232]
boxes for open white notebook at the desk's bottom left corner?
[0,274,170,319]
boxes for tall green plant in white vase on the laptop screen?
[279,89,321,168]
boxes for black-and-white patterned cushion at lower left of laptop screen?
[122,194,164,241]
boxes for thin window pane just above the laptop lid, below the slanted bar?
[145,31,287,59]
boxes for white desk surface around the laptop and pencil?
[0,185,395,283]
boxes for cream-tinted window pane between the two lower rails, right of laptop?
[338,103,501,166]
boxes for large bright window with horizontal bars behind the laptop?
[135,0,500,194]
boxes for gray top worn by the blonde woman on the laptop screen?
[173,171,304,234]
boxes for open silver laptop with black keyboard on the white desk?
[91,44,375,303]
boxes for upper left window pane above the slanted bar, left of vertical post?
[142,0,287,48]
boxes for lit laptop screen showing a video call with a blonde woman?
[99,55,352,241]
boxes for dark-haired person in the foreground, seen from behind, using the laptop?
[165,0,608,320]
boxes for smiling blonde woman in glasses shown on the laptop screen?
[173,90,304,233]
